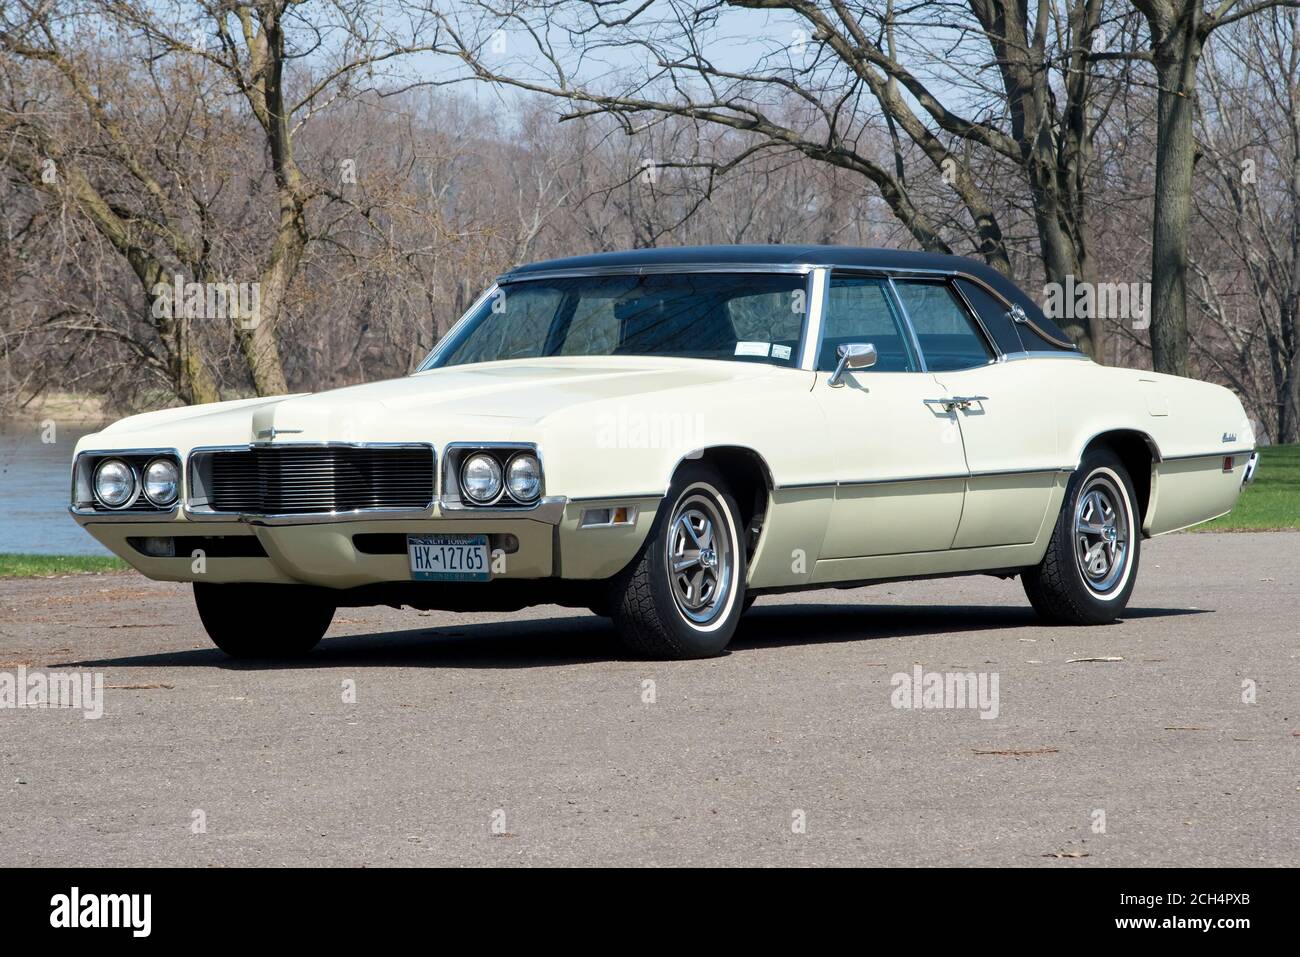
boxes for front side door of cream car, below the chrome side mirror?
[813,273,966,559]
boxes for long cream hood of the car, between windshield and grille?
[83,356,807,449]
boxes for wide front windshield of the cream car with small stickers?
[421,273,807,368]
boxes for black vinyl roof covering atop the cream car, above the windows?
[501,244,1065,353]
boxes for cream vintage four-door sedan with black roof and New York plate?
[72,246,1256,658]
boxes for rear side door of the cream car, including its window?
[894,280,1062,549]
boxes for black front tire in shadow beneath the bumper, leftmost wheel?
[194,581,334,658]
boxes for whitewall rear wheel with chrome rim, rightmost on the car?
[1021,449,1141,624]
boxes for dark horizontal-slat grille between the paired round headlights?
[208,446,434,515]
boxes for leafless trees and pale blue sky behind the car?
[0,0,1300,441]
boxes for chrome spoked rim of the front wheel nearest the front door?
[667,493,735,625]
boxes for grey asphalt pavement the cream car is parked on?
[0,532,1300,867]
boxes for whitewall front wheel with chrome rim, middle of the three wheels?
[610,462,745,659]
